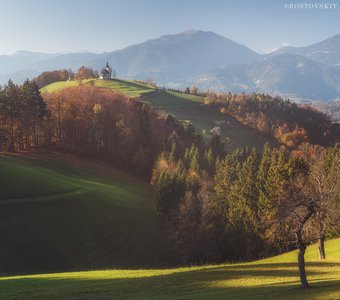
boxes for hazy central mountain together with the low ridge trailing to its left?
[0,30,260,85]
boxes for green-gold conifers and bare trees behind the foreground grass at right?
[151,142,340,287]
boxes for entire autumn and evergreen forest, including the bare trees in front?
[0,75,340,287]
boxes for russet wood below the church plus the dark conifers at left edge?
[0,81,198,175]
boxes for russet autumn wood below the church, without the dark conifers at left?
[44,86,192,174]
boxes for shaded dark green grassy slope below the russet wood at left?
[0,153,175,274]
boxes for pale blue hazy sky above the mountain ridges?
[0,0,340,54]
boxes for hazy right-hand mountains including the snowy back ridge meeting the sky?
[195,34,340,101]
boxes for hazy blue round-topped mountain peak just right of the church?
[102,31,260,84]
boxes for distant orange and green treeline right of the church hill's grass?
[204,93,340,149]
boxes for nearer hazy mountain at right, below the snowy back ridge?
[197,54,340,99]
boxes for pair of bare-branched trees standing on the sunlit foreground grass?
[266,148,340,288]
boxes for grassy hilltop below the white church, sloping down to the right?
[41,79,274,150]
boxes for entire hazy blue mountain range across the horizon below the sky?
[0,30,340,101]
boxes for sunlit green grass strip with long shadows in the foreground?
[0,239,340,300]
